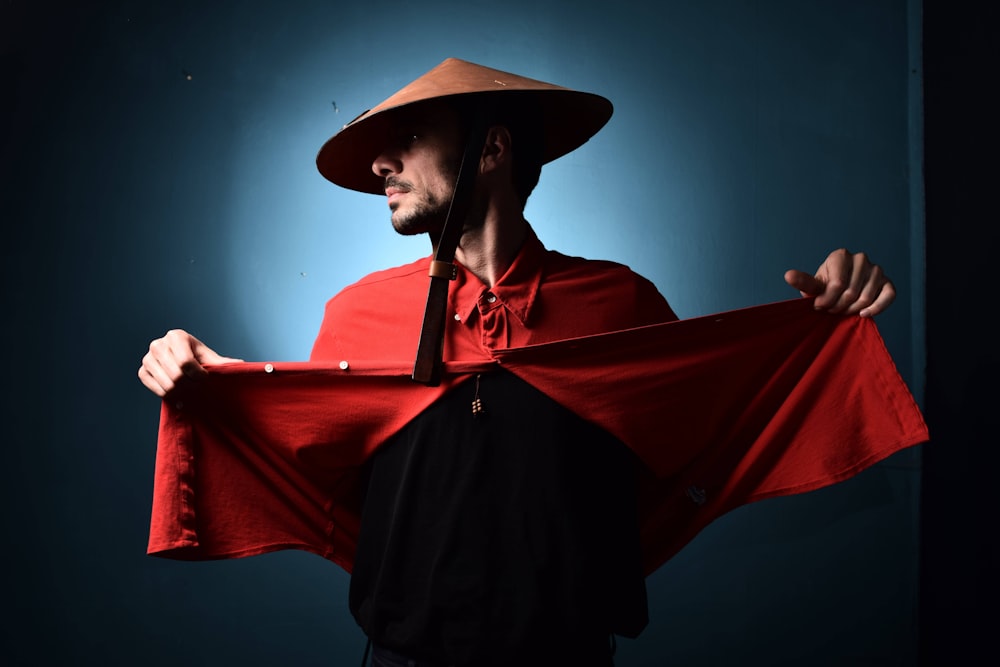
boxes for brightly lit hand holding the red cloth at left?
[139,329,243,397]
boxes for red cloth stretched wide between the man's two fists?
[149,299,928,573]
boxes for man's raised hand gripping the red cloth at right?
[785,248,896,317]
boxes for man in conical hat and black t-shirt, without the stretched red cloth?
[145,59,895,665]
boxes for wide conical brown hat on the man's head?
[316,58,613,194]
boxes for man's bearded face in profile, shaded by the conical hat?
[372,105,462,235]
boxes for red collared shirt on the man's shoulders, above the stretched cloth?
[311,229,677,364]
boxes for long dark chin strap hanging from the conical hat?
[412,117,487,387]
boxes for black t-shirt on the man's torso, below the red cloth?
[350,372,647,665]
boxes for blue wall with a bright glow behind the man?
[0,0,924,667]
